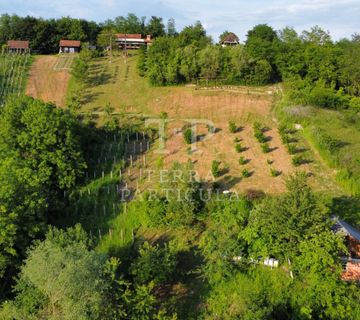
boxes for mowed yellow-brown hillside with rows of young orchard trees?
[76,55,339,193]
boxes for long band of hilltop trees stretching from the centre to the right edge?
[139,23,360,108]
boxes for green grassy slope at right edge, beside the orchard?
[281,107,360,195]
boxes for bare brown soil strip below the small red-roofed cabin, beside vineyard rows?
[26,56,70,107]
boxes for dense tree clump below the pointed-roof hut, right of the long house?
[139,22,286,85]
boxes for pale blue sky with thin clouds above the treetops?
[0,0,360,40]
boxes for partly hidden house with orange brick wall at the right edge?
[332,217,360,281]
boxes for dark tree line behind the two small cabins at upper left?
[0,13,176,54]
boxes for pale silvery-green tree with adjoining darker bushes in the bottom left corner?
[0,225,176,320]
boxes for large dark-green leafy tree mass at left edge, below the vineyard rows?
[0,97,86,296]
